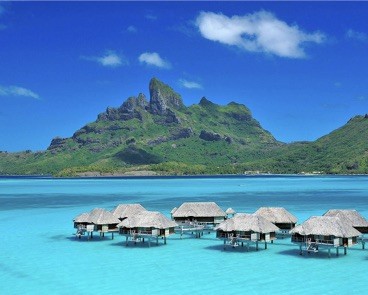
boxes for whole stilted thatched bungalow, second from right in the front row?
[216,213,279,250]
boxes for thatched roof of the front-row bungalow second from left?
[117,211,177,229]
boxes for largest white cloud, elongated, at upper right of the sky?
[196,11,325,58]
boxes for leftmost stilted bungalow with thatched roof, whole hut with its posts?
[73,208,120,238]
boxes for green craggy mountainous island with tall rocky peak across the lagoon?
[0,78,368,177]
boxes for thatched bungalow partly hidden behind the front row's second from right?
[254,207,298,237]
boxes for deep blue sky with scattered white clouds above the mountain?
[0,2,368,151]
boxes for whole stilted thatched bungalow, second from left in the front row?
[117,211,177,246]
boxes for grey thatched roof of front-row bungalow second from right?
[216,213,279,233]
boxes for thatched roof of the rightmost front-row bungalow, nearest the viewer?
[290,216,361,238]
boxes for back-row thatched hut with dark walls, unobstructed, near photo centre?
[172,202,226,226]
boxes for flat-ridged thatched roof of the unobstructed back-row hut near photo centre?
[173,202,226,217]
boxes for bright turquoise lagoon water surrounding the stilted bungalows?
[0,176,368,295]
